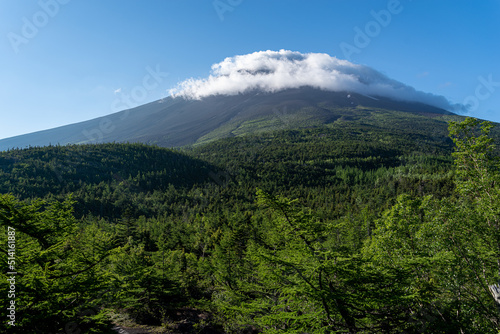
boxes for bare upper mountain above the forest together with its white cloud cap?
[0,50,455,150]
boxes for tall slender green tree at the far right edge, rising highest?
[448,118,500,330]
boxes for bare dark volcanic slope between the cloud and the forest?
[0,88,450,150]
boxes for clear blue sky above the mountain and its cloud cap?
[0,0,500,138]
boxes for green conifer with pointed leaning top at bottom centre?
[215,191,418,333]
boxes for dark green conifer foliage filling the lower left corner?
[0,195,118,333]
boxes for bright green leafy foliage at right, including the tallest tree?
[364,119,500,333]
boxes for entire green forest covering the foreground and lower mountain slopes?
[0,118,500,334]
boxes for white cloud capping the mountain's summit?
[169,50,459,110]
